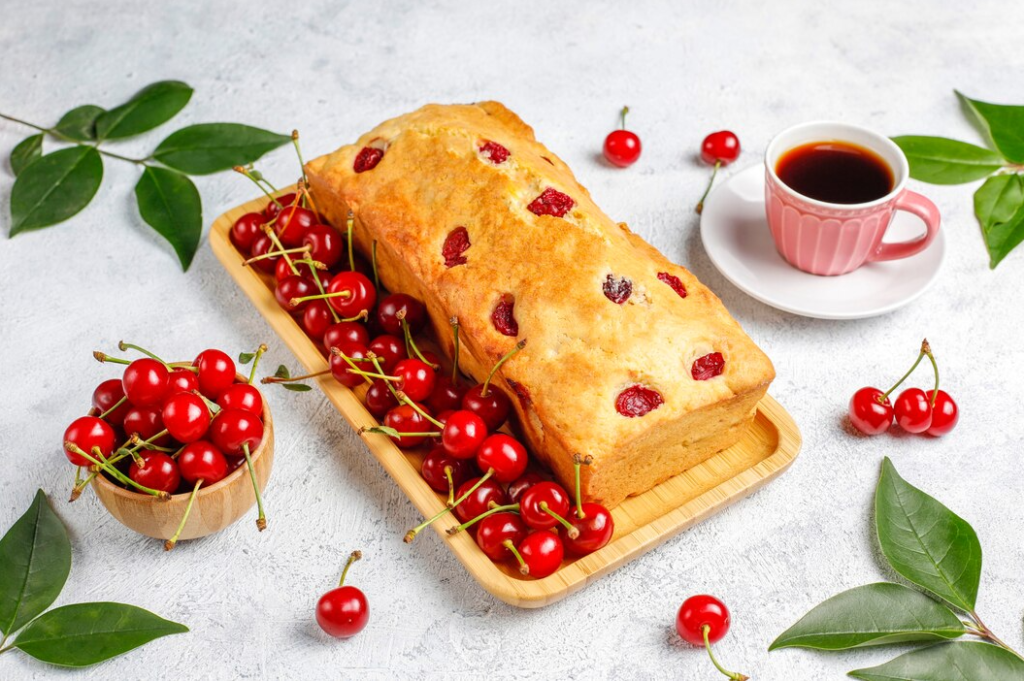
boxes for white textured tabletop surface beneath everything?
[0,0,1024,681]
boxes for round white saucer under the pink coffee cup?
[700,165,946,320]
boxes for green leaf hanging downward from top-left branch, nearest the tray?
[135,166,203,270]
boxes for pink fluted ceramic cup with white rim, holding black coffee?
[765,122,939,275]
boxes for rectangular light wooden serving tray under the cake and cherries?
[210,188,801,607]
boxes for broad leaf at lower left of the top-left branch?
[10,146,103,237]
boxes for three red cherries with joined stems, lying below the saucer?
[849,339,959,437]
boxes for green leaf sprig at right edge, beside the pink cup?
[893,92,1024,269]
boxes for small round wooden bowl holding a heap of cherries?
[92,376,273,540]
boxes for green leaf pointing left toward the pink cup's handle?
[893,135,1006,184]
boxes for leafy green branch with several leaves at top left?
[0,81,292,270]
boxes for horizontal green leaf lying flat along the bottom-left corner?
[13,603,188,667]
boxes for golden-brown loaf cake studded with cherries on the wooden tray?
[306,101,774,507]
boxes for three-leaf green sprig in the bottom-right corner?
[769,458,1024,681]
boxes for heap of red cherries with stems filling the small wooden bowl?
[63,342,266,550]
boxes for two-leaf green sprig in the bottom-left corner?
[0,490,188,667]
